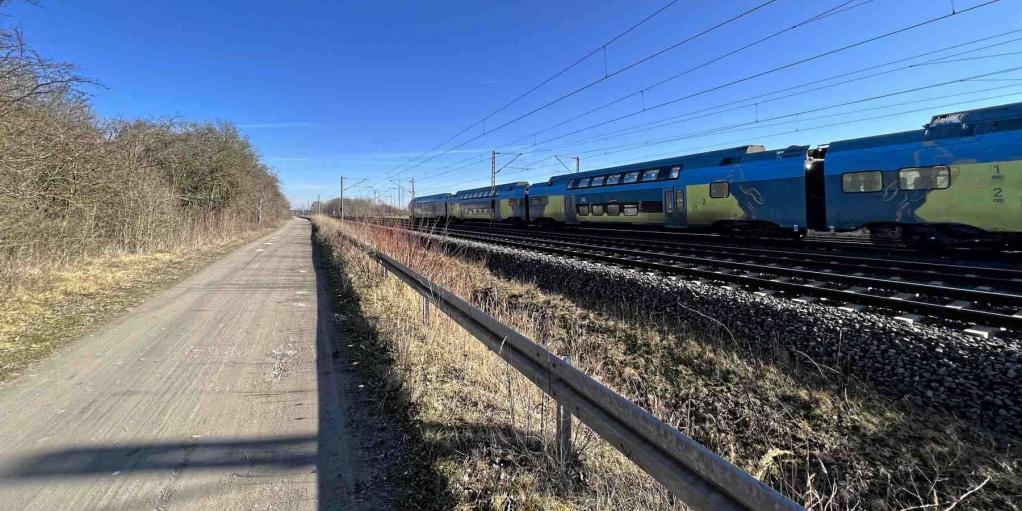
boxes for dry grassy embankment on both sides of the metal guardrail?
[317,219,1022,510]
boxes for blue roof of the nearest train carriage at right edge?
[828,102,1022,152]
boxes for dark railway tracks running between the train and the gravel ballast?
[355,218,1022,337]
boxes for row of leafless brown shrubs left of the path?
[0,9,286,285]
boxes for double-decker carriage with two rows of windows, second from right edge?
[528,145,808,232]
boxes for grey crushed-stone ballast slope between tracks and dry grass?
[410,229,1022,434]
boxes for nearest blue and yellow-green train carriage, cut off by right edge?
[825,103,1022,248]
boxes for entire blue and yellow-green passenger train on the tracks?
[409,103,1022,247]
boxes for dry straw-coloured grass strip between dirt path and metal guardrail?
[317,218,682,510]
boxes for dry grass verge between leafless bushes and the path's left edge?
[0,229,270,381]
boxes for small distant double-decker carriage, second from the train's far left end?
[447,181,528,224]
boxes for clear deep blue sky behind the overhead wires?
[3,0,1022,203]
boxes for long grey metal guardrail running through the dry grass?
[342,230,803,510]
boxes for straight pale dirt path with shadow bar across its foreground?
[0,219,394,511]
